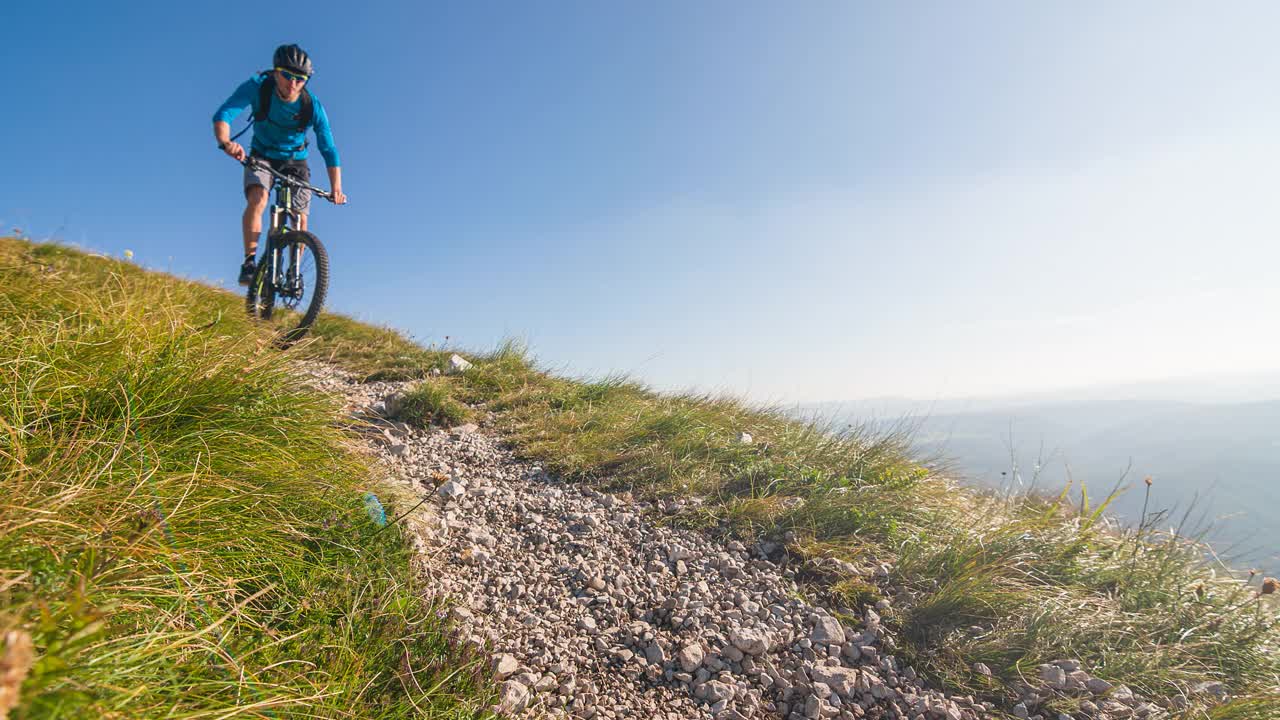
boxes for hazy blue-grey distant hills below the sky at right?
[803,388,1280,574]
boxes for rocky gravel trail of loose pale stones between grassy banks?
[314,366,991,720]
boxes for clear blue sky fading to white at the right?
[0,0,1280,402]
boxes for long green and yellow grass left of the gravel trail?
[0,240,489,719]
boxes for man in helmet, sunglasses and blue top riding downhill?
[214,45,347,284]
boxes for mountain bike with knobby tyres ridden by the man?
[241,156,333,346]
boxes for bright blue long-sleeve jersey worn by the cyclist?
[214,73,339,168]
